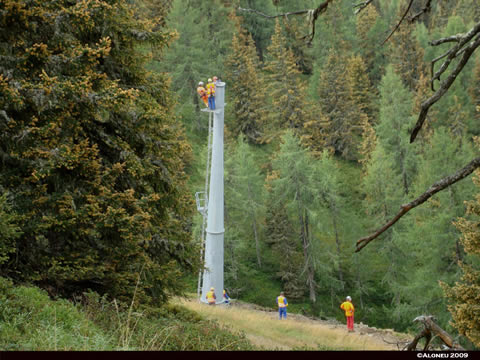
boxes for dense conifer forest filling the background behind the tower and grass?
[0,0,480,347]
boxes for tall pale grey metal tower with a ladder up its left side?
[196,82,225,304]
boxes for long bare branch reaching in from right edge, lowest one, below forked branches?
[355,157,480,252]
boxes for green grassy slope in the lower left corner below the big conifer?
[0,277,254,351]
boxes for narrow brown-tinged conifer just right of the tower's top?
[226,16,267,143]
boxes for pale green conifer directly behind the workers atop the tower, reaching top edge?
[160,0,234,132]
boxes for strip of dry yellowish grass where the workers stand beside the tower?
[175,299,412,350]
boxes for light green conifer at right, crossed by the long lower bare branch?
[391,127,474,327]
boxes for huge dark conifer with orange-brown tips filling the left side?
[0,0,195,301]
